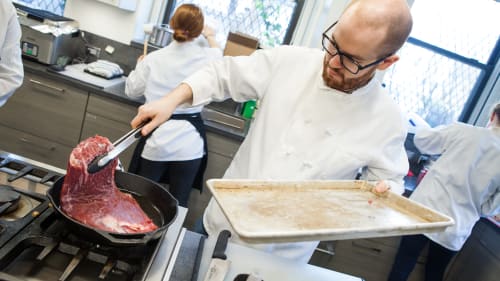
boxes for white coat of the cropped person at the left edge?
[0,0,24,106]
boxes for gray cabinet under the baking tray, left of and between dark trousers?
[309,237,426,281]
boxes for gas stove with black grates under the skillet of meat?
[0,151,187,281]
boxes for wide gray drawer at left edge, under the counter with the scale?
[0,72,88,146]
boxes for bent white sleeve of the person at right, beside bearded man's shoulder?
[413,126,451,155]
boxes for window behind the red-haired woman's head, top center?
[163,0,304,47]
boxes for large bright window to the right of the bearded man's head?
[384,0,500,126]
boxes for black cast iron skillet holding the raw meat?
[47,171,178,247]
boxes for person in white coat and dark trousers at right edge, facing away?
[389,103,500,281]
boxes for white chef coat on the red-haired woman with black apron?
[125,41,222,161]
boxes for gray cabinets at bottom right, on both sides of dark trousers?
[310,219,500,281]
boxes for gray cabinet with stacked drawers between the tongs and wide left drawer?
[81,93,137,170]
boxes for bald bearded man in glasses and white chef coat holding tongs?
[131,0,412,263]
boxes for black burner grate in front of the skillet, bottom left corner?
[0,208,157,281]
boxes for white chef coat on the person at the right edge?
[410,123,500,251]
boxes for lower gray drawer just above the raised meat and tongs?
[82,113,137,170]
